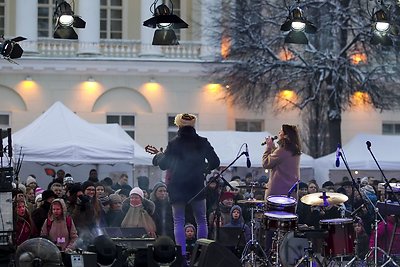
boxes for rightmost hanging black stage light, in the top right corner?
[371,4,398,46]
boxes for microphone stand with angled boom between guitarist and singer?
[188,152,246,240]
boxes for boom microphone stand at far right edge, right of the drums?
[365,141,400,267]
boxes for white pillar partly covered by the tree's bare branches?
[200,0,223,60]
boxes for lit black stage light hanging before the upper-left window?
[53,0,86,39]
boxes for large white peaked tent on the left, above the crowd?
[3,102,135,164]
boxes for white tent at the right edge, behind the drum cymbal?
[314,134,400,184]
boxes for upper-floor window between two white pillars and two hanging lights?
[100,0,122,39]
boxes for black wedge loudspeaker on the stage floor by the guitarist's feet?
[190,239,242,267]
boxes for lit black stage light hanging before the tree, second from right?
[281,7,317,44]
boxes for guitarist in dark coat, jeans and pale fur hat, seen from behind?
[153,114,220,257]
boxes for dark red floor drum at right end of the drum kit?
[319,218,355,258]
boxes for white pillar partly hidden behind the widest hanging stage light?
[140,0,162,57]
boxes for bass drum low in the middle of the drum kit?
[279,232,308,267]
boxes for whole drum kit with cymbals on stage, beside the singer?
[234,185,356,267]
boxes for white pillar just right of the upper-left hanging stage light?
[74,0,100,55]
